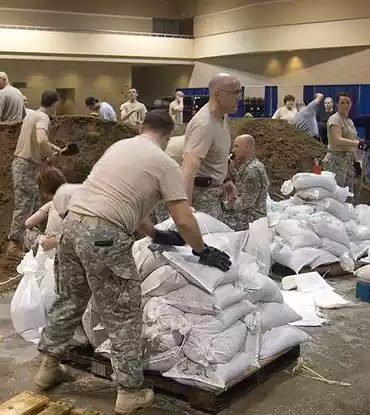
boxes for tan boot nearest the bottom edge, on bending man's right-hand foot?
[114,389,154,415]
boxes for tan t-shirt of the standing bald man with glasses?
[184,104,231,184]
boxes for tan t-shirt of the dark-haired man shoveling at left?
[14,110,50,164]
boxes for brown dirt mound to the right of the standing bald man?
[237,118,326,196]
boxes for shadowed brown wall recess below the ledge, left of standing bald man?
[132,65,193,104]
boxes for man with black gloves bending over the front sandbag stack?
[35,111,231,414]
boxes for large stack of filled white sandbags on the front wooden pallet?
[83,213,308,391]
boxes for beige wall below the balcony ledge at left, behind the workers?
[0,60,131,114]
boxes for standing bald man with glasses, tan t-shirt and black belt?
[182,73,241,219]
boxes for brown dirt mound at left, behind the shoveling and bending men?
[0,116,137,252]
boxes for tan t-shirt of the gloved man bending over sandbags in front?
[69,136,187,233]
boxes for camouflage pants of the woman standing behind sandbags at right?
[323,151,354,192]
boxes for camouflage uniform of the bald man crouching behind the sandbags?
[223,157,270,231]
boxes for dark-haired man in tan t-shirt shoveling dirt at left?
[7,90,60,260]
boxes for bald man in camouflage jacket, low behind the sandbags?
[223,134,270,231]
